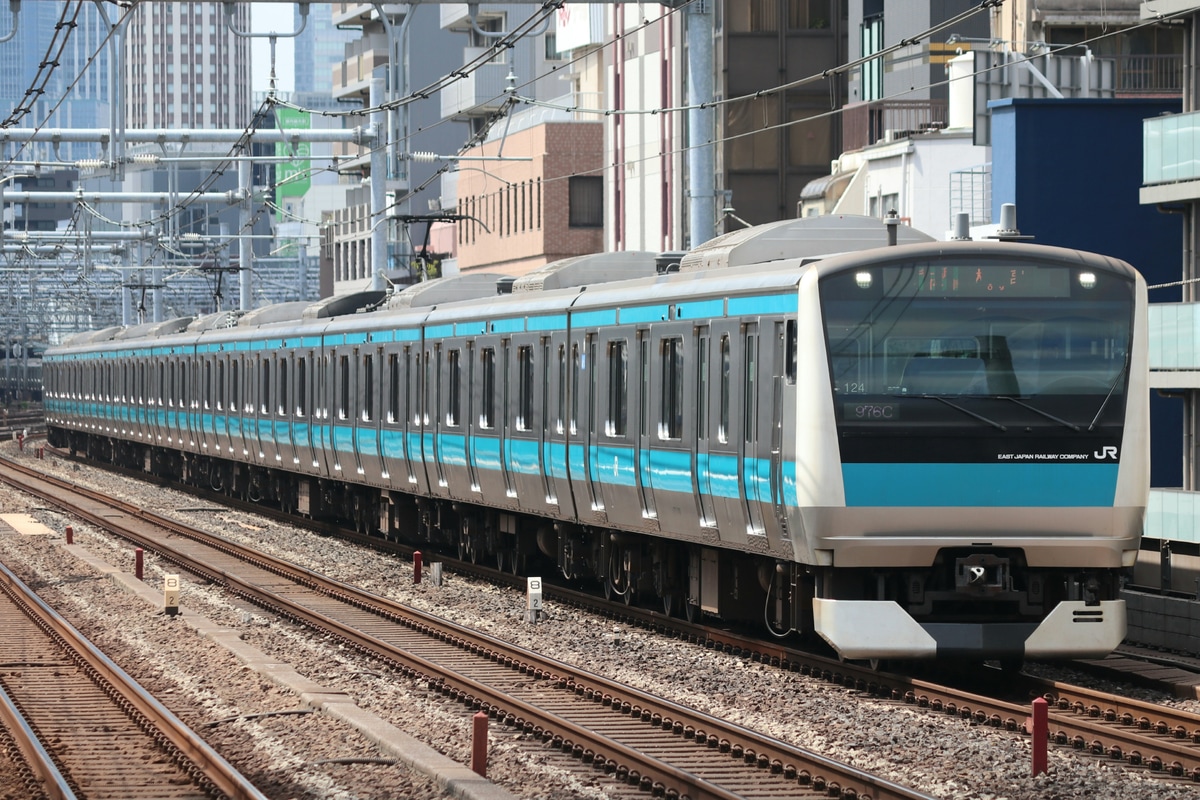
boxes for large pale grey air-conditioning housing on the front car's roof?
[679,215,937,272]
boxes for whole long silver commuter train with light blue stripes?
[44,217,1148,662]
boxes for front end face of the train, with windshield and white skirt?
[797,242,1148,663]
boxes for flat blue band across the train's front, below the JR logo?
[841,463,1117,507]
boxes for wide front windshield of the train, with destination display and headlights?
[821,260,1134,412]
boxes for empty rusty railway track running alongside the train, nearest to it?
[0,450,930,800]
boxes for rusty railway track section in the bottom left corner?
[0,554,264,800]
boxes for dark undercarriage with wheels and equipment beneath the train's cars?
[50,428,1123,663]
